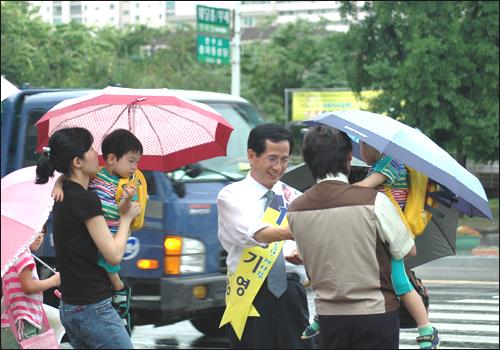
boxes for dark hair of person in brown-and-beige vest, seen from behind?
[302,125,352,180]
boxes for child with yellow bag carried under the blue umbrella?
[302,142,439,349]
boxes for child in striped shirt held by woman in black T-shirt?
[53,129,143,333]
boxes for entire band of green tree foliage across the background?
[1,1,499,167]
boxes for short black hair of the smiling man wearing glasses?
[247,123,293,157]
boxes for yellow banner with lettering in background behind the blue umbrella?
[292,90,380,121]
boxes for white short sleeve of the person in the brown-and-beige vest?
[375,193,415,260]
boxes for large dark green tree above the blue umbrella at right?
[342,1,499,165]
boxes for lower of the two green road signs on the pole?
[196,34,230,64]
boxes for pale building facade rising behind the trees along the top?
[30,1,363,31]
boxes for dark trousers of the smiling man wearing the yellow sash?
[226,273,314,349]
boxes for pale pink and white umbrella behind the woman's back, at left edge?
[1,166,57,277]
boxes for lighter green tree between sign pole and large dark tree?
[242,20,345,122]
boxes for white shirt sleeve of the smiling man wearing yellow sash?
[217,188,269,248]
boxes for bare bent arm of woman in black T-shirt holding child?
[85,202,141,265]
